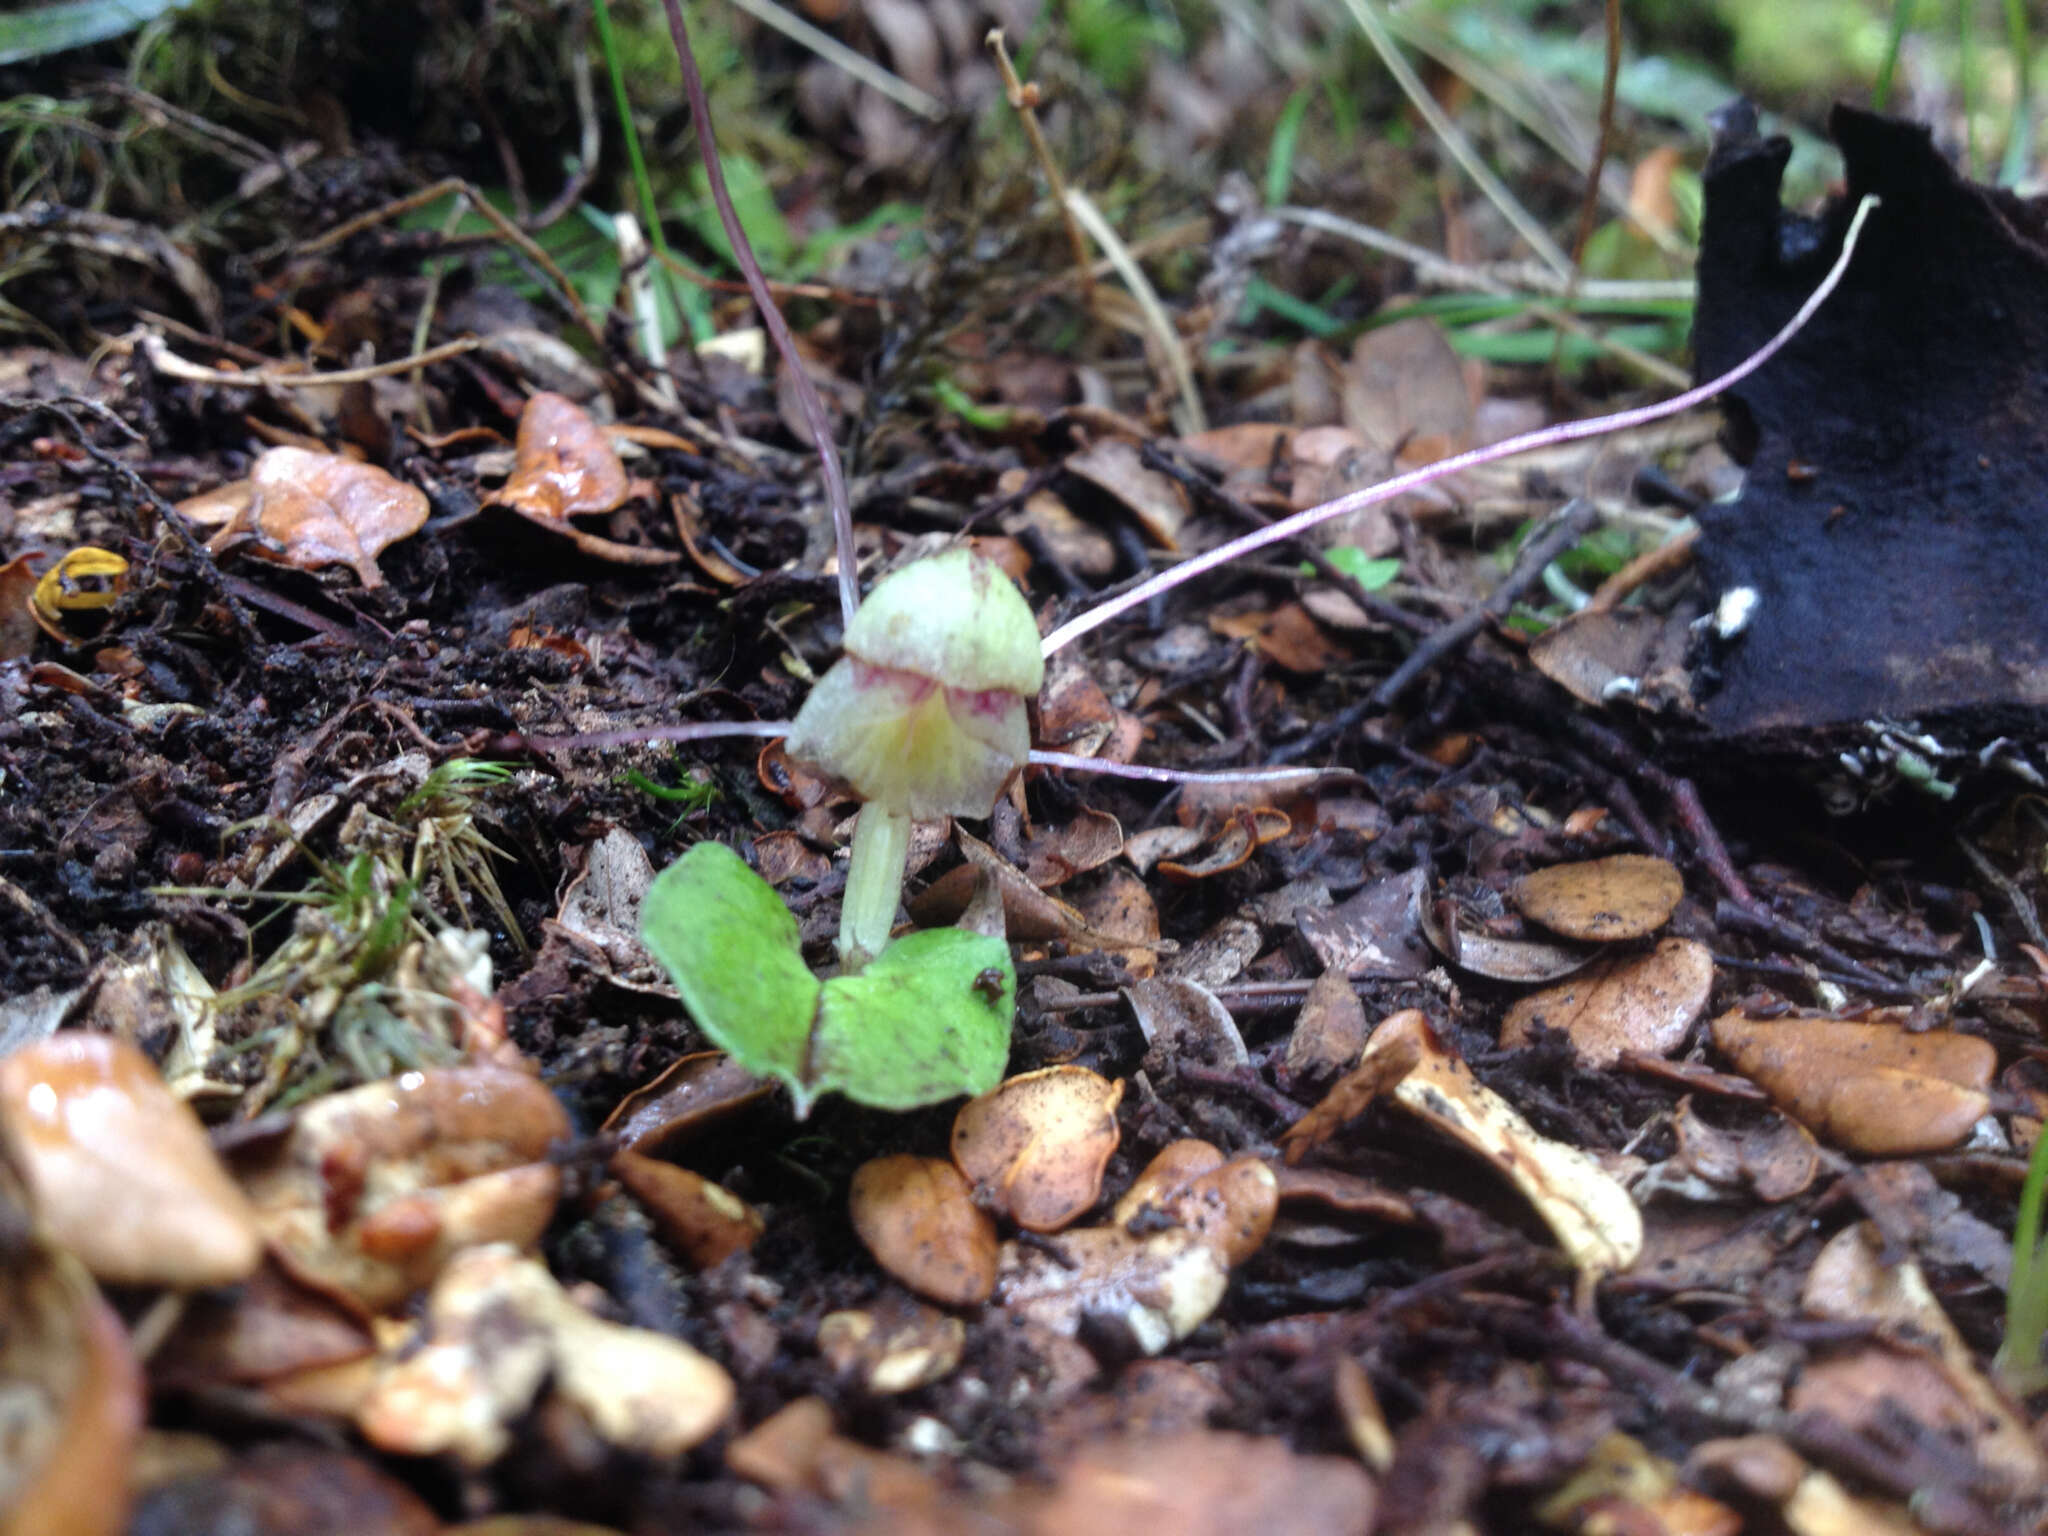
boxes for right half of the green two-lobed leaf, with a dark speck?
[799,928,1018,1110]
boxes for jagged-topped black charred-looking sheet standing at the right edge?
[1694,104,2048,741]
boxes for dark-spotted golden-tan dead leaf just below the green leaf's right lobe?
[952,1067,1124,1233]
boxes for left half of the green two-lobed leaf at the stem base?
[641,842,819,1104]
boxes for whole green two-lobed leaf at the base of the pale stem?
[641,842,1016,1116]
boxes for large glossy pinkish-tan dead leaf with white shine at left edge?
[0,1030,262,1290]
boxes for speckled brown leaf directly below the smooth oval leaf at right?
[1501,938,1714,1069]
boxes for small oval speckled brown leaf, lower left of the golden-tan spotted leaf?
[848,1153,995,1307]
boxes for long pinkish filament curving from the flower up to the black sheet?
[1040,197,1878,655]
